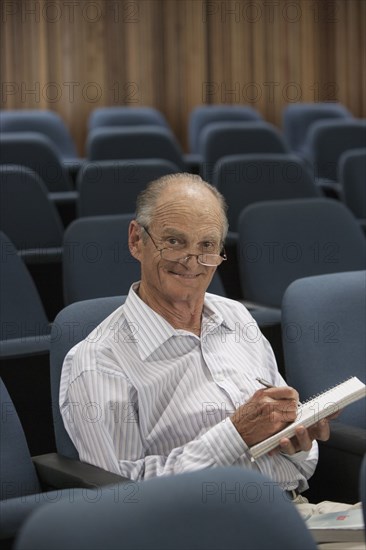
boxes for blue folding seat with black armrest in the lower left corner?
[0,378,123,548]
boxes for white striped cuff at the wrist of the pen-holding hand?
[202,418,248,466]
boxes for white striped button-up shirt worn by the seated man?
[60,285,318,490]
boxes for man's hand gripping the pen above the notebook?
[230,386,299,447]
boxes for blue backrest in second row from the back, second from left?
[87,125,186,170]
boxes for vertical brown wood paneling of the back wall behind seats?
[0,0,366,154]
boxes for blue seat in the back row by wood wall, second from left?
[88,105,169,132]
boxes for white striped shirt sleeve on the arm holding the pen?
[61,358,247,480]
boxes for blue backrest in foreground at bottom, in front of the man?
[17,467,316,550]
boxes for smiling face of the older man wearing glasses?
[132,186,222,303]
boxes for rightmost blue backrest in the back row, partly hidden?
[282,102,353,152]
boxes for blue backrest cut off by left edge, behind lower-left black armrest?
[0,378,40,500]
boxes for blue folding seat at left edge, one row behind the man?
[0,231,52,460]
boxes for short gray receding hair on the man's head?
[136,172,229,243]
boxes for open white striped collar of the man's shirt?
[123,283,234,360]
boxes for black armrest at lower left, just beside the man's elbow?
[32,453,131,489]
